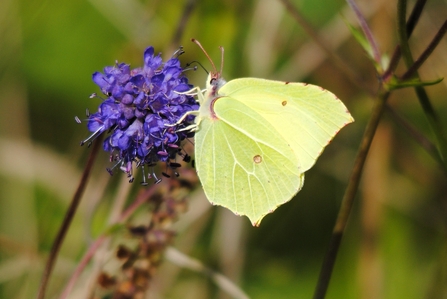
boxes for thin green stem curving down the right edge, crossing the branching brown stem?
[397,0,447,167]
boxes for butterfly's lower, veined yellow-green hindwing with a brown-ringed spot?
[195,97,304,225]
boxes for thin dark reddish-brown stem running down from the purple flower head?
[37,137,102,299]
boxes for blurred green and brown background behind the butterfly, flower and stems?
[0,0,447,299]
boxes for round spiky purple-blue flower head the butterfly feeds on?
[81,47,199,184]
